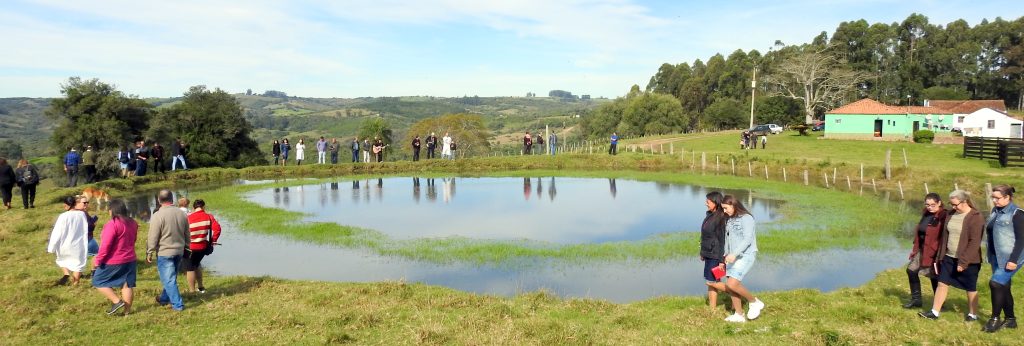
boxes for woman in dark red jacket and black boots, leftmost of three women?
[903,192,946,309]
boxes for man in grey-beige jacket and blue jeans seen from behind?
[145,189,189,311]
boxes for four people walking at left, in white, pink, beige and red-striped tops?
[46,189,221,314]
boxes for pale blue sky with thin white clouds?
[0,0,1024,97]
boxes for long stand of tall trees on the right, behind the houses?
[583,13,1024,137]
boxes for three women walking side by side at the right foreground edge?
[903,185,1024,333]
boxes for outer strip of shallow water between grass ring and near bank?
[203,220,905,302]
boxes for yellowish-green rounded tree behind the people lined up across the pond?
[401,114,490,156]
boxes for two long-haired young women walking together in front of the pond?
[699,191,765,322]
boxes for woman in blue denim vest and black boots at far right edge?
[983,185,1024,333]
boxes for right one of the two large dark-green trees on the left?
[146,85,266,167]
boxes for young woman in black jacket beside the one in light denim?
[700,191,726,308]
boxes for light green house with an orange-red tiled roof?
[824,98,955,140]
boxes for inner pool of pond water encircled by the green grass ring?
[246,177,781,244]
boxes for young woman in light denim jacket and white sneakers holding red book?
[722,196,765,322]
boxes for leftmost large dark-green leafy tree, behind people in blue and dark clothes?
[46,77,153,153]
